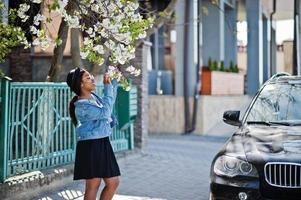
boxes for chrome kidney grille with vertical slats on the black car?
[264,162,301,188]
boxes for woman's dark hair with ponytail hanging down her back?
[66,67,85,126]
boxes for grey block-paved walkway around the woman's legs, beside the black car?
[35,135,226,200]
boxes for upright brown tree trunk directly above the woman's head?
[71,28,84,67]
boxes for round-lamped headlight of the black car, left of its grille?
[214,156,258,177]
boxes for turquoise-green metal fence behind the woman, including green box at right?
[0,79,137,182]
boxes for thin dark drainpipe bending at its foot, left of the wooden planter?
[190,0,201,132]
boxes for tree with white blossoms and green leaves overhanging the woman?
[0,0,176,88]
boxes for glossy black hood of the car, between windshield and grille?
[242,125,301,162]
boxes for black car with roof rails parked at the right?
[210,73,301,200]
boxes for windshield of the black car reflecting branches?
[246,83,301,126]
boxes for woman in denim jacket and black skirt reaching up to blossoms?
[67,68,120,200]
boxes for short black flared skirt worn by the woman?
[73,137,120,180]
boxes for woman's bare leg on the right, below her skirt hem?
[99,176,119,200]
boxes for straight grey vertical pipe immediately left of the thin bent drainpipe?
[183,0,191,134]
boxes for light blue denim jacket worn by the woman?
[74,79,117,141]
